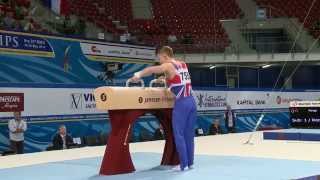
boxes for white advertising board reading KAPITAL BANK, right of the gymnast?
[194,91,320,111]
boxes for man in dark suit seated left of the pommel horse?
[52,125,74,150]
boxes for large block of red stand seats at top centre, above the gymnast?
[71,0,240,51]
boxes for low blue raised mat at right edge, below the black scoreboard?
[263,129,320,141]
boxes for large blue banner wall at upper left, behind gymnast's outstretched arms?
[0,30,152,87]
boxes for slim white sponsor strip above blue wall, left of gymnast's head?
[80,43,156,61]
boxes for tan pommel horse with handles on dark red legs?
[94,80,179,175]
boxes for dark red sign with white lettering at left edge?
[0,93,24,112]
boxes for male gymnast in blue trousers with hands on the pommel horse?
[131,46,197,171]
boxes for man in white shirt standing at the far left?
[8,112,27,154]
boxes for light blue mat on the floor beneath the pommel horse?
[0,153,320,180]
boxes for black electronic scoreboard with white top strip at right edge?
[289,101,320,129]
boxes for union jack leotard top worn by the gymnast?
[167,61,192,99]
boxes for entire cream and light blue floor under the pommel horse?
[0,132,320,180]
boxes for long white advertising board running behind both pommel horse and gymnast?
[0,88,320,117]
